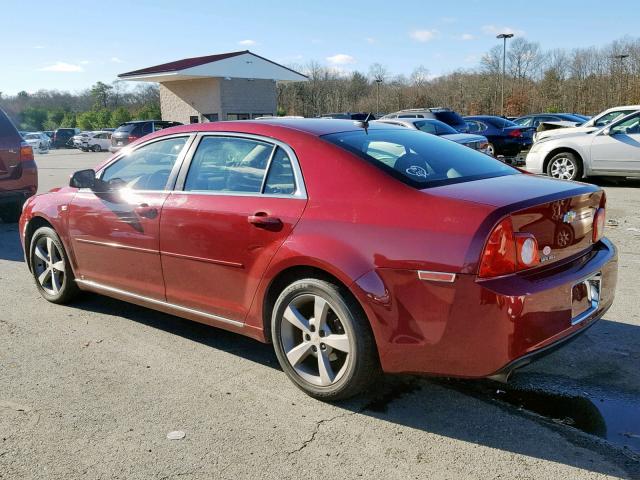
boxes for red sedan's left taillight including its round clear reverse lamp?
[478,217,540,278]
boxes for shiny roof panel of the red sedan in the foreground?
[159,118,397,136]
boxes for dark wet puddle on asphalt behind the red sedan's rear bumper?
[441,380,640,453]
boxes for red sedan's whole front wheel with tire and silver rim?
[29,227,80,304]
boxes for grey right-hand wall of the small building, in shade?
[220,78,278,120]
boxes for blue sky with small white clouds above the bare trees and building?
[0,0,640,94]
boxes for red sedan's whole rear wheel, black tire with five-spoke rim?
[271,278,380,401]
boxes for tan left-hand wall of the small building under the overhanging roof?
[160,78,222,124]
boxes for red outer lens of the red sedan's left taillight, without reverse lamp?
[478,218,517,278]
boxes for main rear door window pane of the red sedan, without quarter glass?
[184,137,273,193]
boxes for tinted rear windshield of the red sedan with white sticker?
[322,129,520,188]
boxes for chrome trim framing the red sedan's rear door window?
[173,131,307,199]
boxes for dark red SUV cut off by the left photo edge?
[0,109,38,223]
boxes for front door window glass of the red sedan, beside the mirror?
[100,137,188,190]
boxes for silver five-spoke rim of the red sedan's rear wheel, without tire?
[280,293,353,387]
